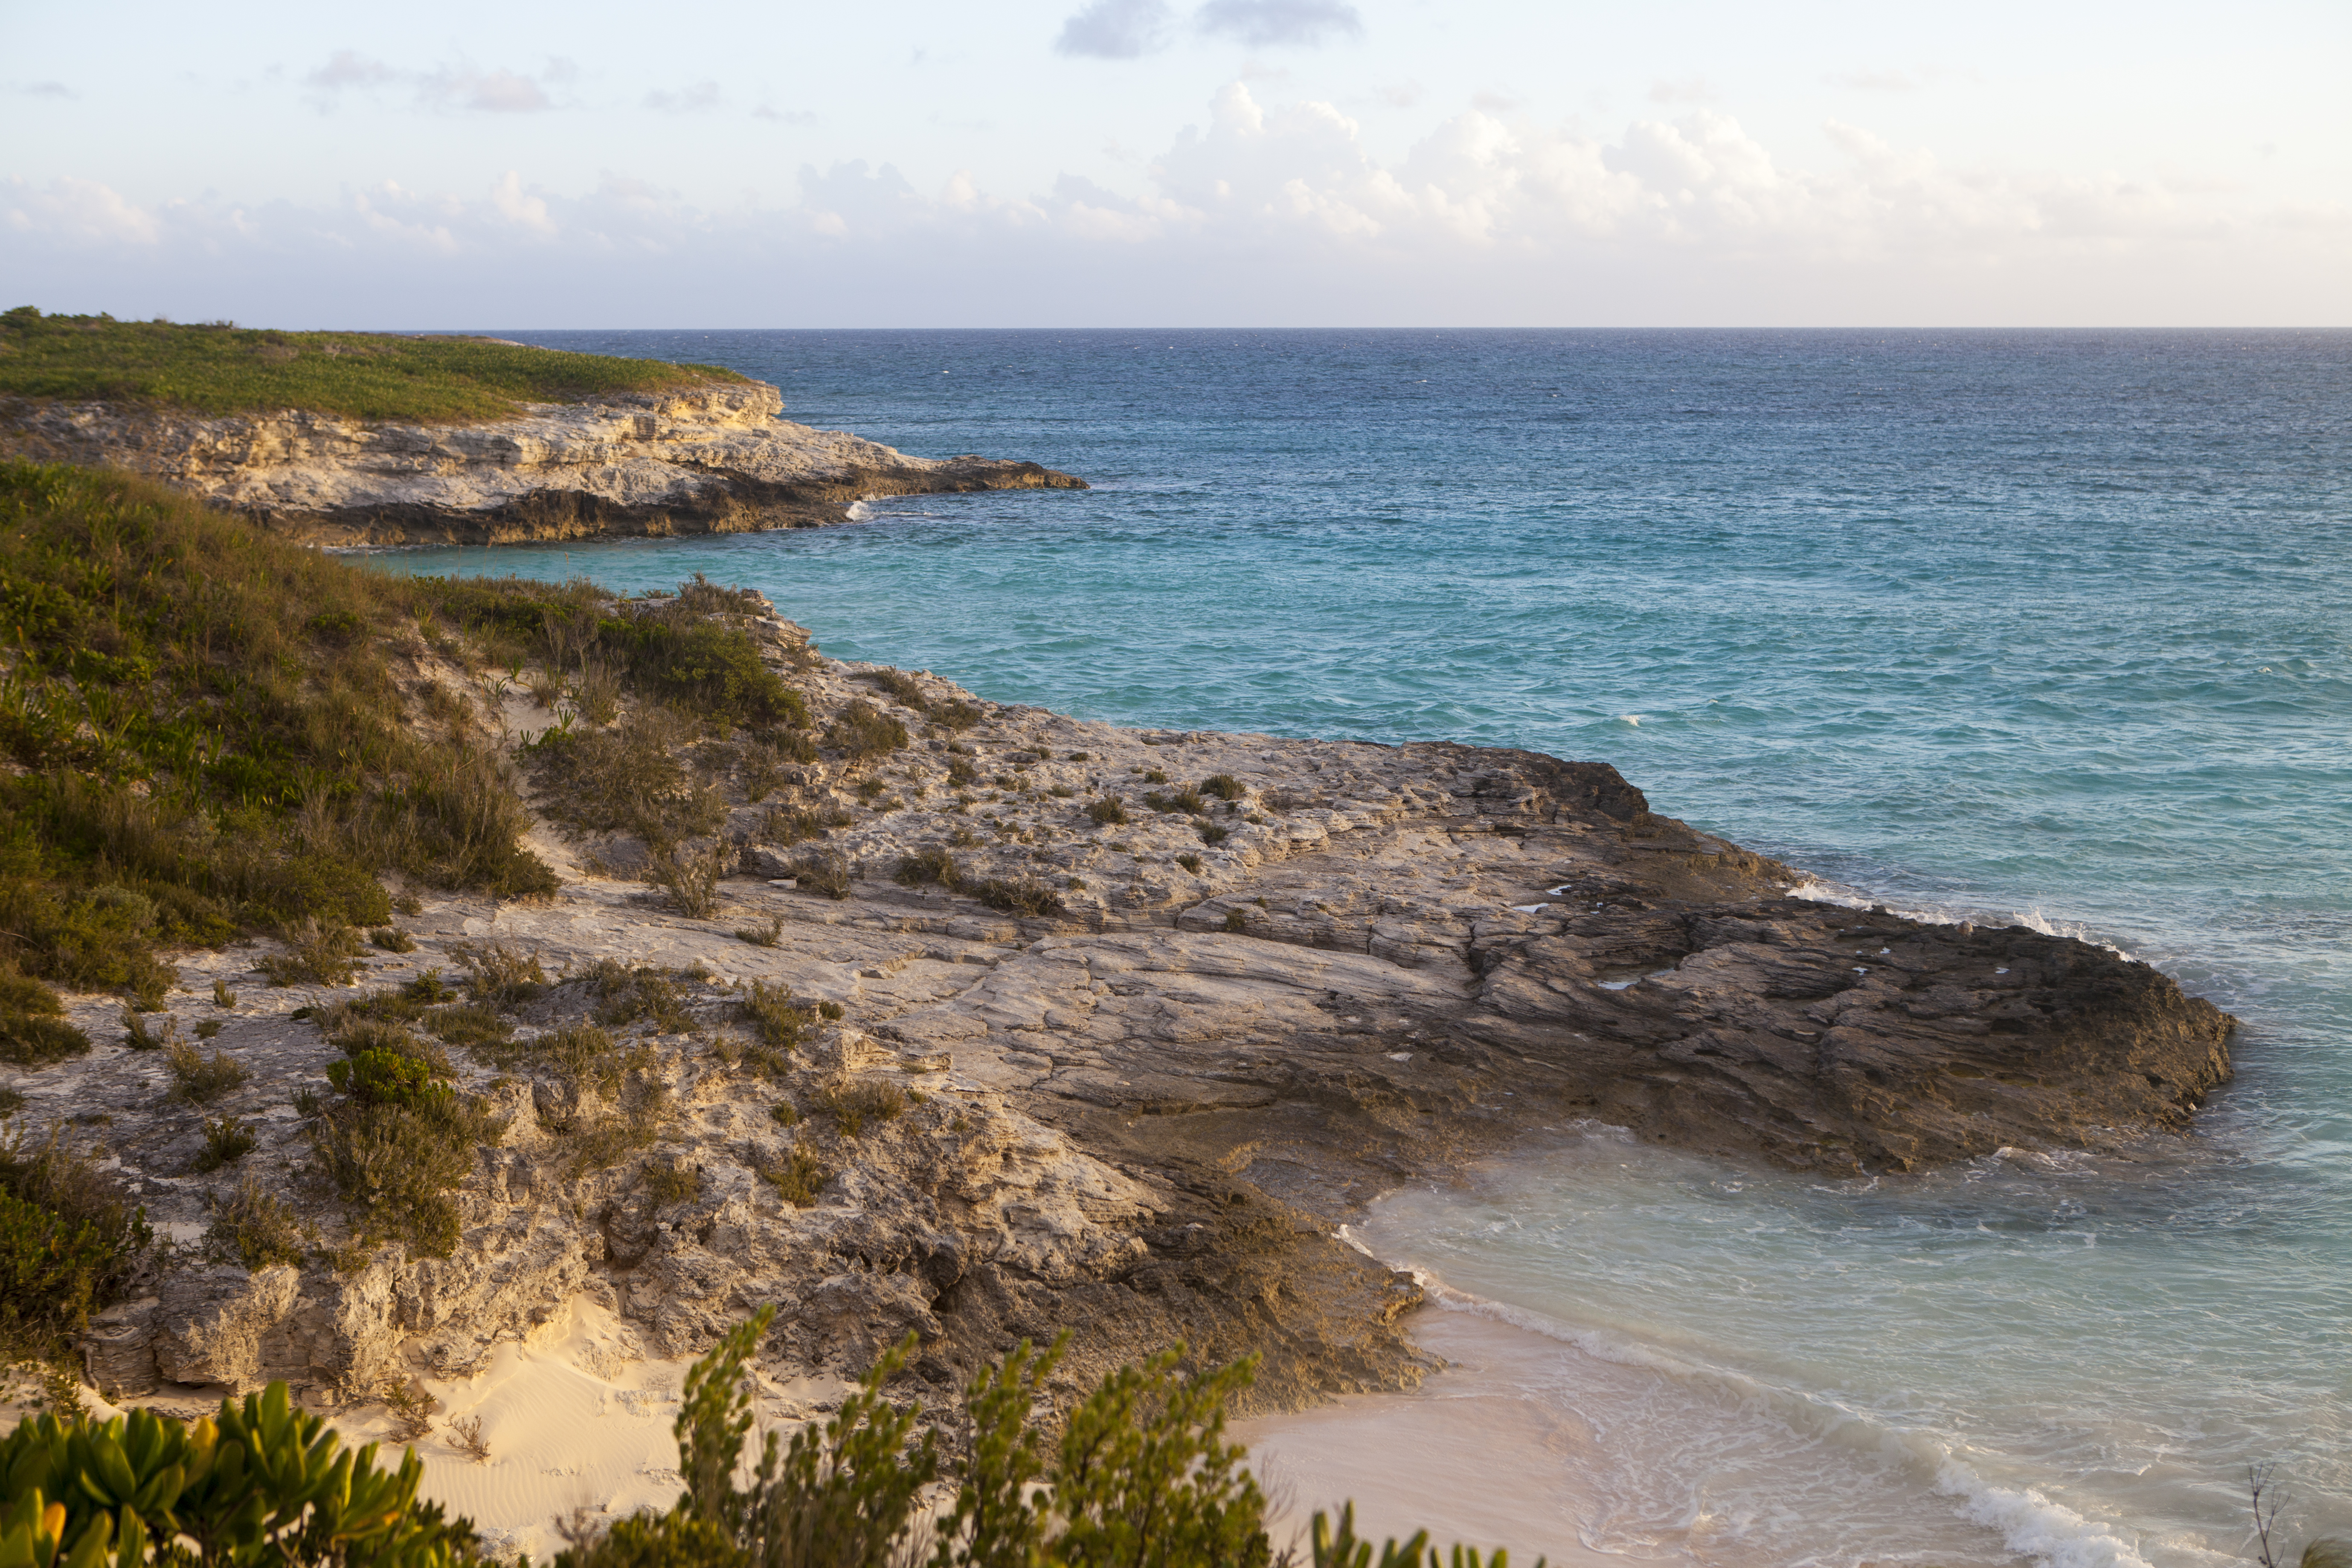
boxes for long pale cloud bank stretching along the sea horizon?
[0,82,2352,327]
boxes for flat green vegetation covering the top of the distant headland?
[0,305,746,423]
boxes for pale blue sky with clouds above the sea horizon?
[0,0,2352,329]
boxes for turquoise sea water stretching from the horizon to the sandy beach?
[395,331,2352,1563]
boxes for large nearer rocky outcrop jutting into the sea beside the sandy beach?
[14,595,2232,1415]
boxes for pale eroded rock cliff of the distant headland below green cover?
[0,381,1086,546]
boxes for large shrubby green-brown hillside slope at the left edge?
[0,463,555,1010]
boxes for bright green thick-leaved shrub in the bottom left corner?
[0,1382,487,1568]
